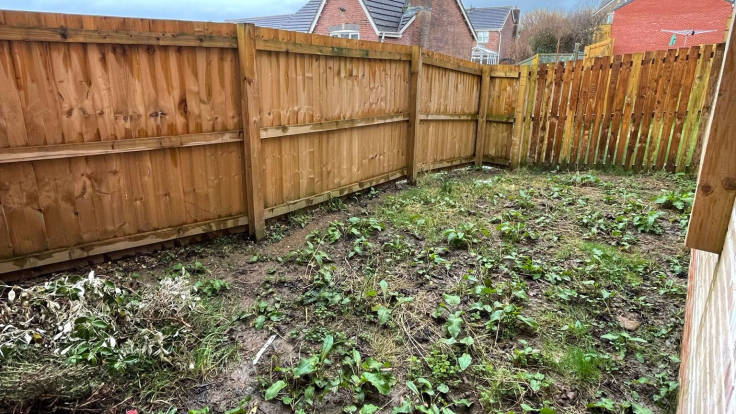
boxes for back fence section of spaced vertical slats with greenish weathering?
[518,44,725,171]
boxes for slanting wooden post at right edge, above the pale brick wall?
[685,12,736,254]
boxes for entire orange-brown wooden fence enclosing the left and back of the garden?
[0,11,722,275]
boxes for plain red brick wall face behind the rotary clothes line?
[611,0,733,55]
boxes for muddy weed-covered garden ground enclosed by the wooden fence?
[0,168,695,414]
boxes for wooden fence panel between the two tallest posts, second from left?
[256,29,411,217]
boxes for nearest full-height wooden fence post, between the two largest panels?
[238,23,266,240]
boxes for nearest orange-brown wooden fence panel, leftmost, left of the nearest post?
[0,12,246,271]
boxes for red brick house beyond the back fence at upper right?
[586,0,733,55]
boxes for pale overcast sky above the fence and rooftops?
[0,0,581,21]
